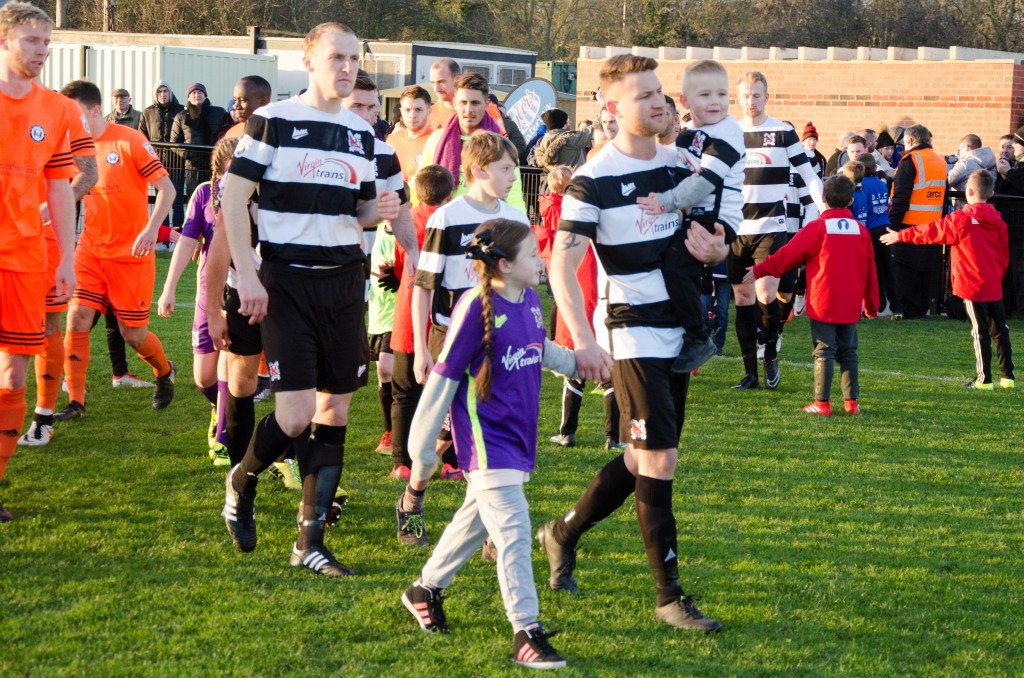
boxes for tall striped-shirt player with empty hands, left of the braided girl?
[221,23,411,577]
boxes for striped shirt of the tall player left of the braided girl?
[228,96,377,266]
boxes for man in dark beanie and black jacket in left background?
[171,82,231,205]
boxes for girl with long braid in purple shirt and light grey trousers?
[396,219,575,669]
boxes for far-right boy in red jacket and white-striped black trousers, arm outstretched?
[880,170,1015,391]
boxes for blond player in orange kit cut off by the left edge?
[0,2,75,522]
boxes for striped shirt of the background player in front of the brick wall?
[739,117,821,236]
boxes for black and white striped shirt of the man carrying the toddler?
[558,143,683,361]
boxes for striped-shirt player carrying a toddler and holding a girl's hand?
[538,54,727,632]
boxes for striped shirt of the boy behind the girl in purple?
[416,196,529,327]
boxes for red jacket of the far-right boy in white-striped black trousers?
[899,203,1010,301]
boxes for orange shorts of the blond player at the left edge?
[0,270,49,355]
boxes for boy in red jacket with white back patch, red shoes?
[743,176,879,417]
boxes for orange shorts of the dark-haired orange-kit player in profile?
[71,247,157,328]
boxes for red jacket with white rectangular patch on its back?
[754,209,879,325]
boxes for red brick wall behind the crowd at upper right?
[577,59,1024,157]
